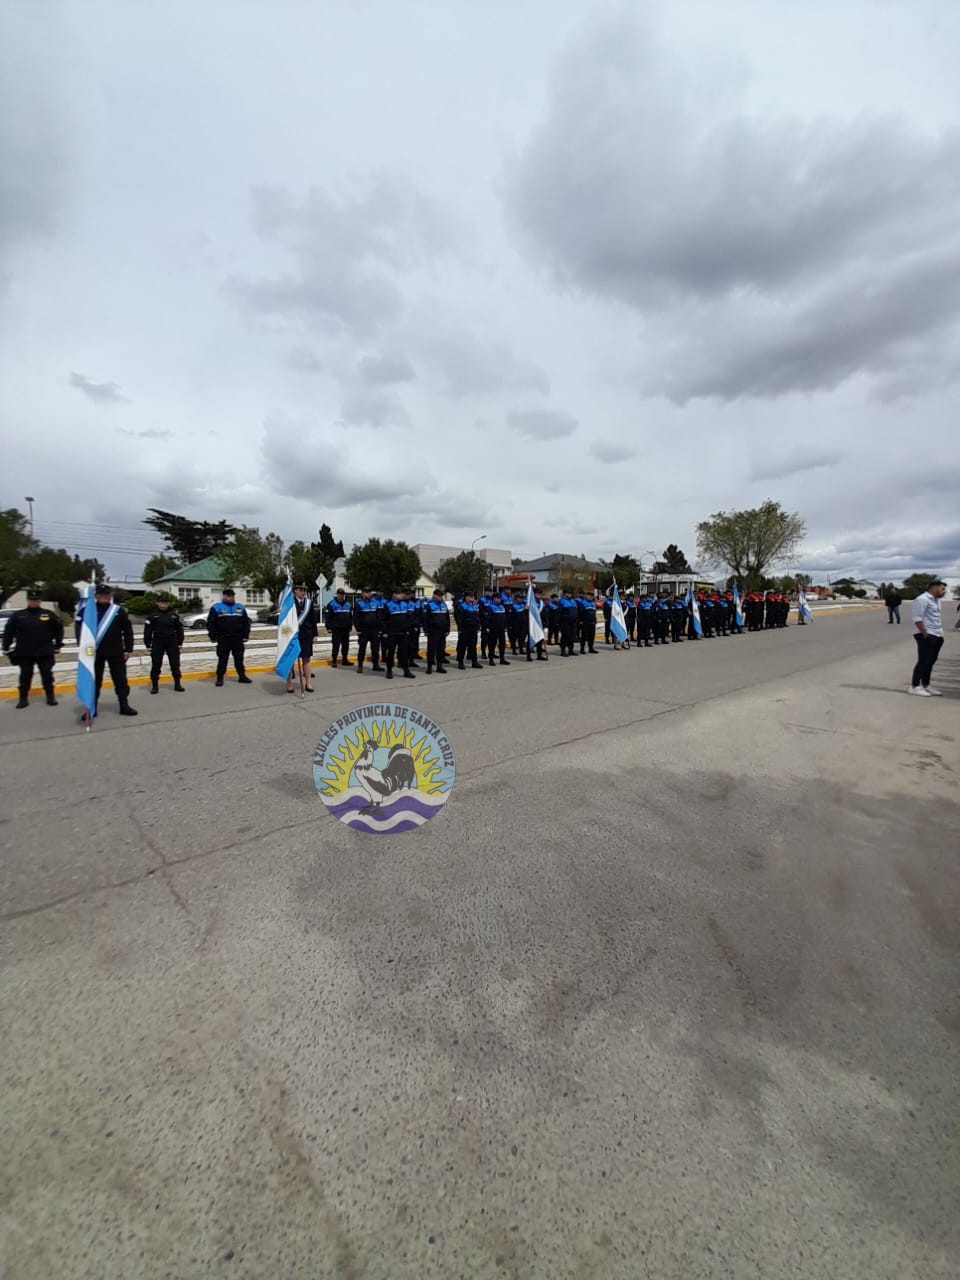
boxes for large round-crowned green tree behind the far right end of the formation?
[696,499,806,588]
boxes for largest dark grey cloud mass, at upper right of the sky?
[508,10,960,403]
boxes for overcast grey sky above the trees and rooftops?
[0,0,960,579]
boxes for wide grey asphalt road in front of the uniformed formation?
[0,613,960,1280]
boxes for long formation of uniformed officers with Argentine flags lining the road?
[3,582,803,716]
